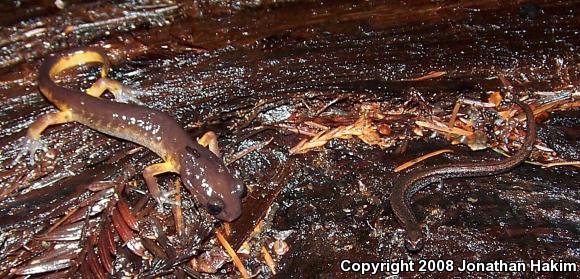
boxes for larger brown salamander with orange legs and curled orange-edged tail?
[15,47,245,222]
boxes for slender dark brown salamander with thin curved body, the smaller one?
[389,100,536,252]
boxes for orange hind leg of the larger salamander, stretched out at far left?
[12,111,72,166]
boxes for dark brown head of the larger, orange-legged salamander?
[180,145,246,222]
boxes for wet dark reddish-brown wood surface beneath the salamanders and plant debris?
[0,1,580,278]
